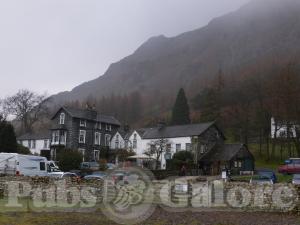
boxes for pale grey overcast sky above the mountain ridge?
[0,0,249,98]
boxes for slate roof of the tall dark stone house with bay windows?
[52,106,121,126]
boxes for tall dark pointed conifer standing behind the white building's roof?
[171,88,191,125]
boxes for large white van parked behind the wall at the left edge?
[0,153,49,176]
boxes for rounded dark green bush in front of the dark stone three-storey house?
[57,149,82,171]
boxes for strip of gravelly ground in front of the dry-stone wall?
[0,209,300,225]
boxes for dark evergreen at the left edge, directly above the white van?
[0,121,18,153]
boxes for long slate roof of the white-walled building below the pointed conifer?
[142,122,215,139]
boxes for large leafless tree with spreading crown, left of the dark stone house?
[2,90,47,132]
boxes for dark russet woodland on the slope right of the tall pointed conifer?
[191,63,300,160]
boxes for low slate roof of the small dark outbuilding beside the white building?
[201,144,251,161]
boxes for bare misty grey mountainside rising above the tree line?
[52,0,300,104]
